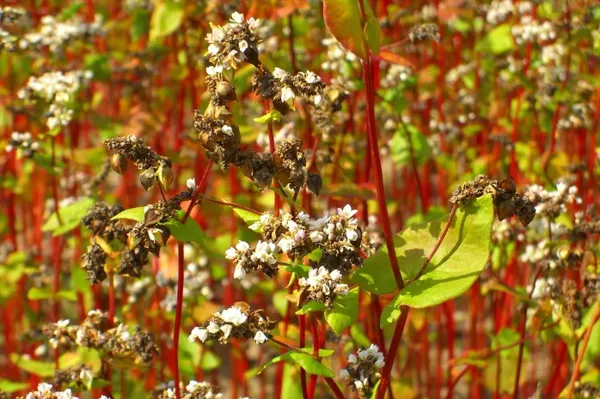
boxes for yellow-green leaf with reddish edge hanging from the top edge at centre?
[323,0,370,59]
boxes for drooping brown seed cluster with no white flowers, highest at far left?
[104,135,173,191]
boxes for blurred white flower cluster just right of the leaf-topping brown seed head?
[525,182,581,219]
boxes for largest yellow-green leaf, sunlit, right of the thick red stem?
[381,195,494,326]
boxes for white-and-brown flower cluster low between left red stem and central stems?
[188,302,276,344]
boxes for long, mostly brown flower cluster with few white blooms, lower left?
[41,310,158,363]
